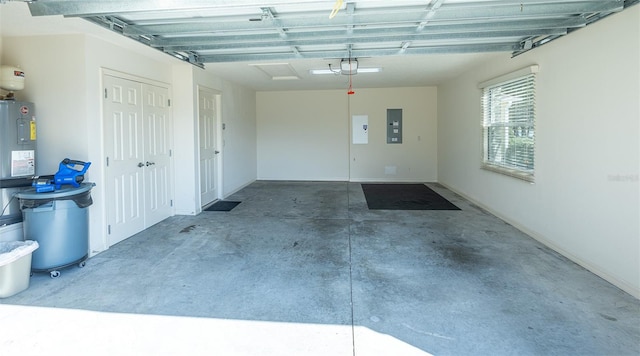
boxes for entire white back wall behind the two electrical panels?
[257,87,437,182]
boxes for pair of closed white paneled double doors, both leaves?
[103,74,172,246]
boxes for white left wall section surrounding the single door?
[173,64,256,215]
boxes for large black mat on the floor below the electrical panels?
[362,184,460,210]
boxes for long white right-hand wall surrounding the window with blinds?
[438,6,640,297]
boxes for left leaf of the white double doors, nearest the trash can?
[103,75,145,246]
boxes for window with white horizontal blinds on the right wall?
[482,67,537,182]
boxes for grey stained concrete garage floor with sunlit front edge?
[0,181,640,355]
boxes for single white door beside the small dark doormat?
[198,88,219,206]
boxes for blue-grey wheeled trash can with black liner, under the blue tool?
[17,183,95,278]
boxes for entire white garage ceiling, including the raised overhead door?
[0,0,637,90]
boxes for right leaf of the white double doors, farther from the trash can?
[142,84,172,227]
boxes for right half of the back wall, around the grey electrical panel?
[349,87,438,182]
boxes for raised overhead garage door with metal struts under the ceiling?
[23,0,639,66]
